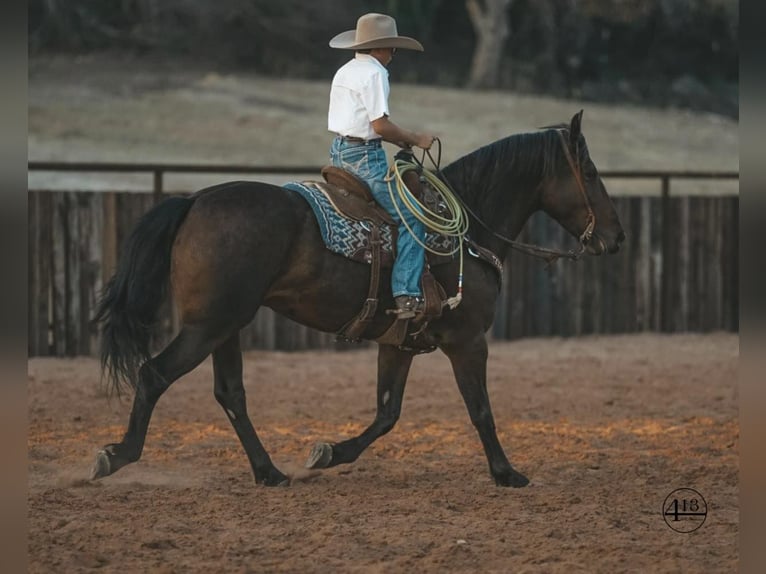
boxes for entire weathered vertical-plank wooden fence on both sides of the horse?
[28,191,739,356]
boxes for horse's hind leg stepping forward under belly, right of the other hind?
[213,332,289,486]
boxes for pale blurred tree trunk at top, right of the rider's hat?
[466,0,512,88]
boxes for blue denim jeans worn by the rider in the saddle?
[330,137,426,297]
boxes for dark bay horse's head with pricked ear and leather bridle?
[540,110,625,255]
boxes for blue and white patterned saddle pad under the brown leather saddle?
[283,181,457,266]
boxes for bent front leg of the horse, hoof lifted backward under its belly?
[306,345,413,468]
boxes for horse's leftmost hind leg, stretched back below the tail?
[91,326,218,478]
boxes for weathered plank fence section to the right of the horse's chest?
[493,196,739,339]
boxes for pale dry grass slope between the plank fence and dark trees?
[28,56,739,195]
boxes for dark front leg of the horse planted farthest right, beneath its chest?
[443,333,529,487]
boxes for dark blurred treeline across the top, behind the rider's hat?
[28,0,739,116]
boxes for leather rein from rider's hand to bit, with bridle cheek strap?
[424,130,596,265]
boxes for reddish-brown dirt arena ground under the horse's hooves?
[28,333,739,573]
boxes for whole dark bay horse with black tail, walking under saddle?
[92,112,625,487]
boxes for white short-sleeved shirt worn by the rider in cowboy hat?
[327,54,390,140]
